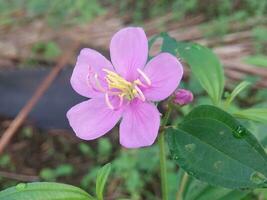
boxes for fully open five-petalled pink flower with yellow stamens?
[67,27,183,148]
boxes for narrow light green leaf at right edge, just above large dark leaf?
[234,108,267,124]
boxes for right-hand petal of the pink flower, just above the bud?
[143,53,183,101]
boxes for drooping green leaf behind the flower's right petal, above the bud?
[162,33,224,104]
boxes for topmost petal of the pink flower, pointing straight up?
[110,27,148,81]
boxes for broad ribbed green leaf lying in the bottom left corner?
[0,182,94,200]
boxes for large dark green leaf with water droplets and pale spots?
[167,105,267,188]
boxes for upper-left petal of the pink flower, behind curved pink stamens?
[70,48,114,98]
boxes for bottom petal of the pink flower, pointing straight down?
[120,101,160,148]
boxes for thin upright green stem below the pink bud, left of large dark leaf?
[158,105,171,200]
